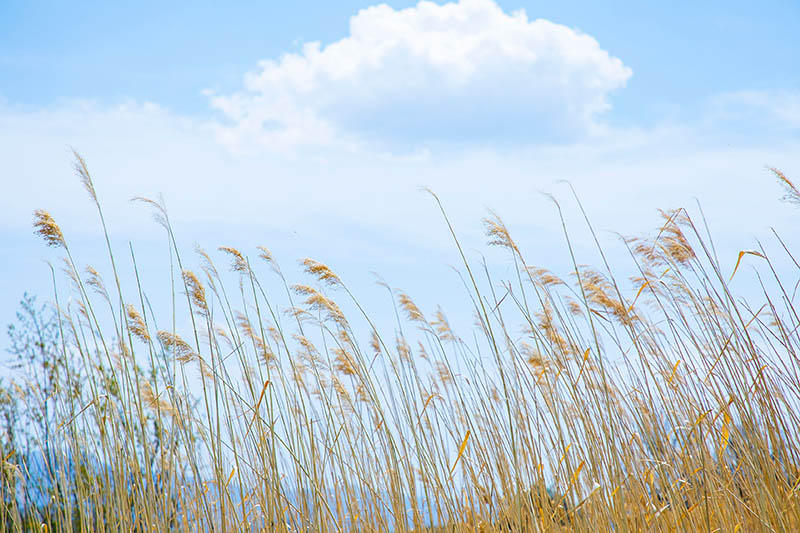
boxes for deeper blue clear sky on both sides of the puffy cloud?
[0,0,800,123]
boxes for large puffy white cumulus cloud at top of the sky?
[211,0,631,147]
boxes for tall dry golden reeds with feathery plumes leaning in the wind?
[0,154,800,532]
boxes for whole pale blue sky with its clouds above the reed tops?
[0,0,800,358]
